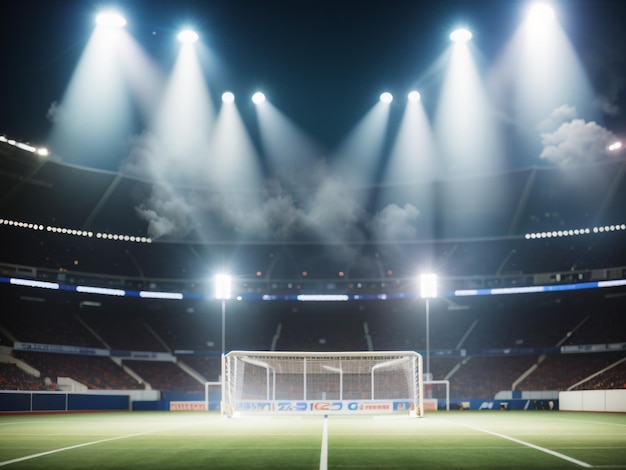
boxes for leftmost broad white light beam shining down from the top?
[48,22,132,168]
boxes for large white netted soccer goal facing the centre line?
[221,351,424,417]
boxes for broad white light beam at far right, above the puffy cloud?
[489,4,598,149]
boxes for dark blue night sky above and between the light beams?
[0,0,626,165]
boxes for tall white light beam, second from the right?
[432,43,507,237]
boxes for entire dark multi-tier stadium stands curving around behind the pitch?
[0,145,626,399]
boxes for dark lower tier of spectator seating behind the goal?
[0,289,626,398]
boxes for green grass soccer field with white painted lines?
[0,411,626,469]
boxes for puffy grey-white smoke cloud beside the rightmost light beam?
[539,106,617,166]
